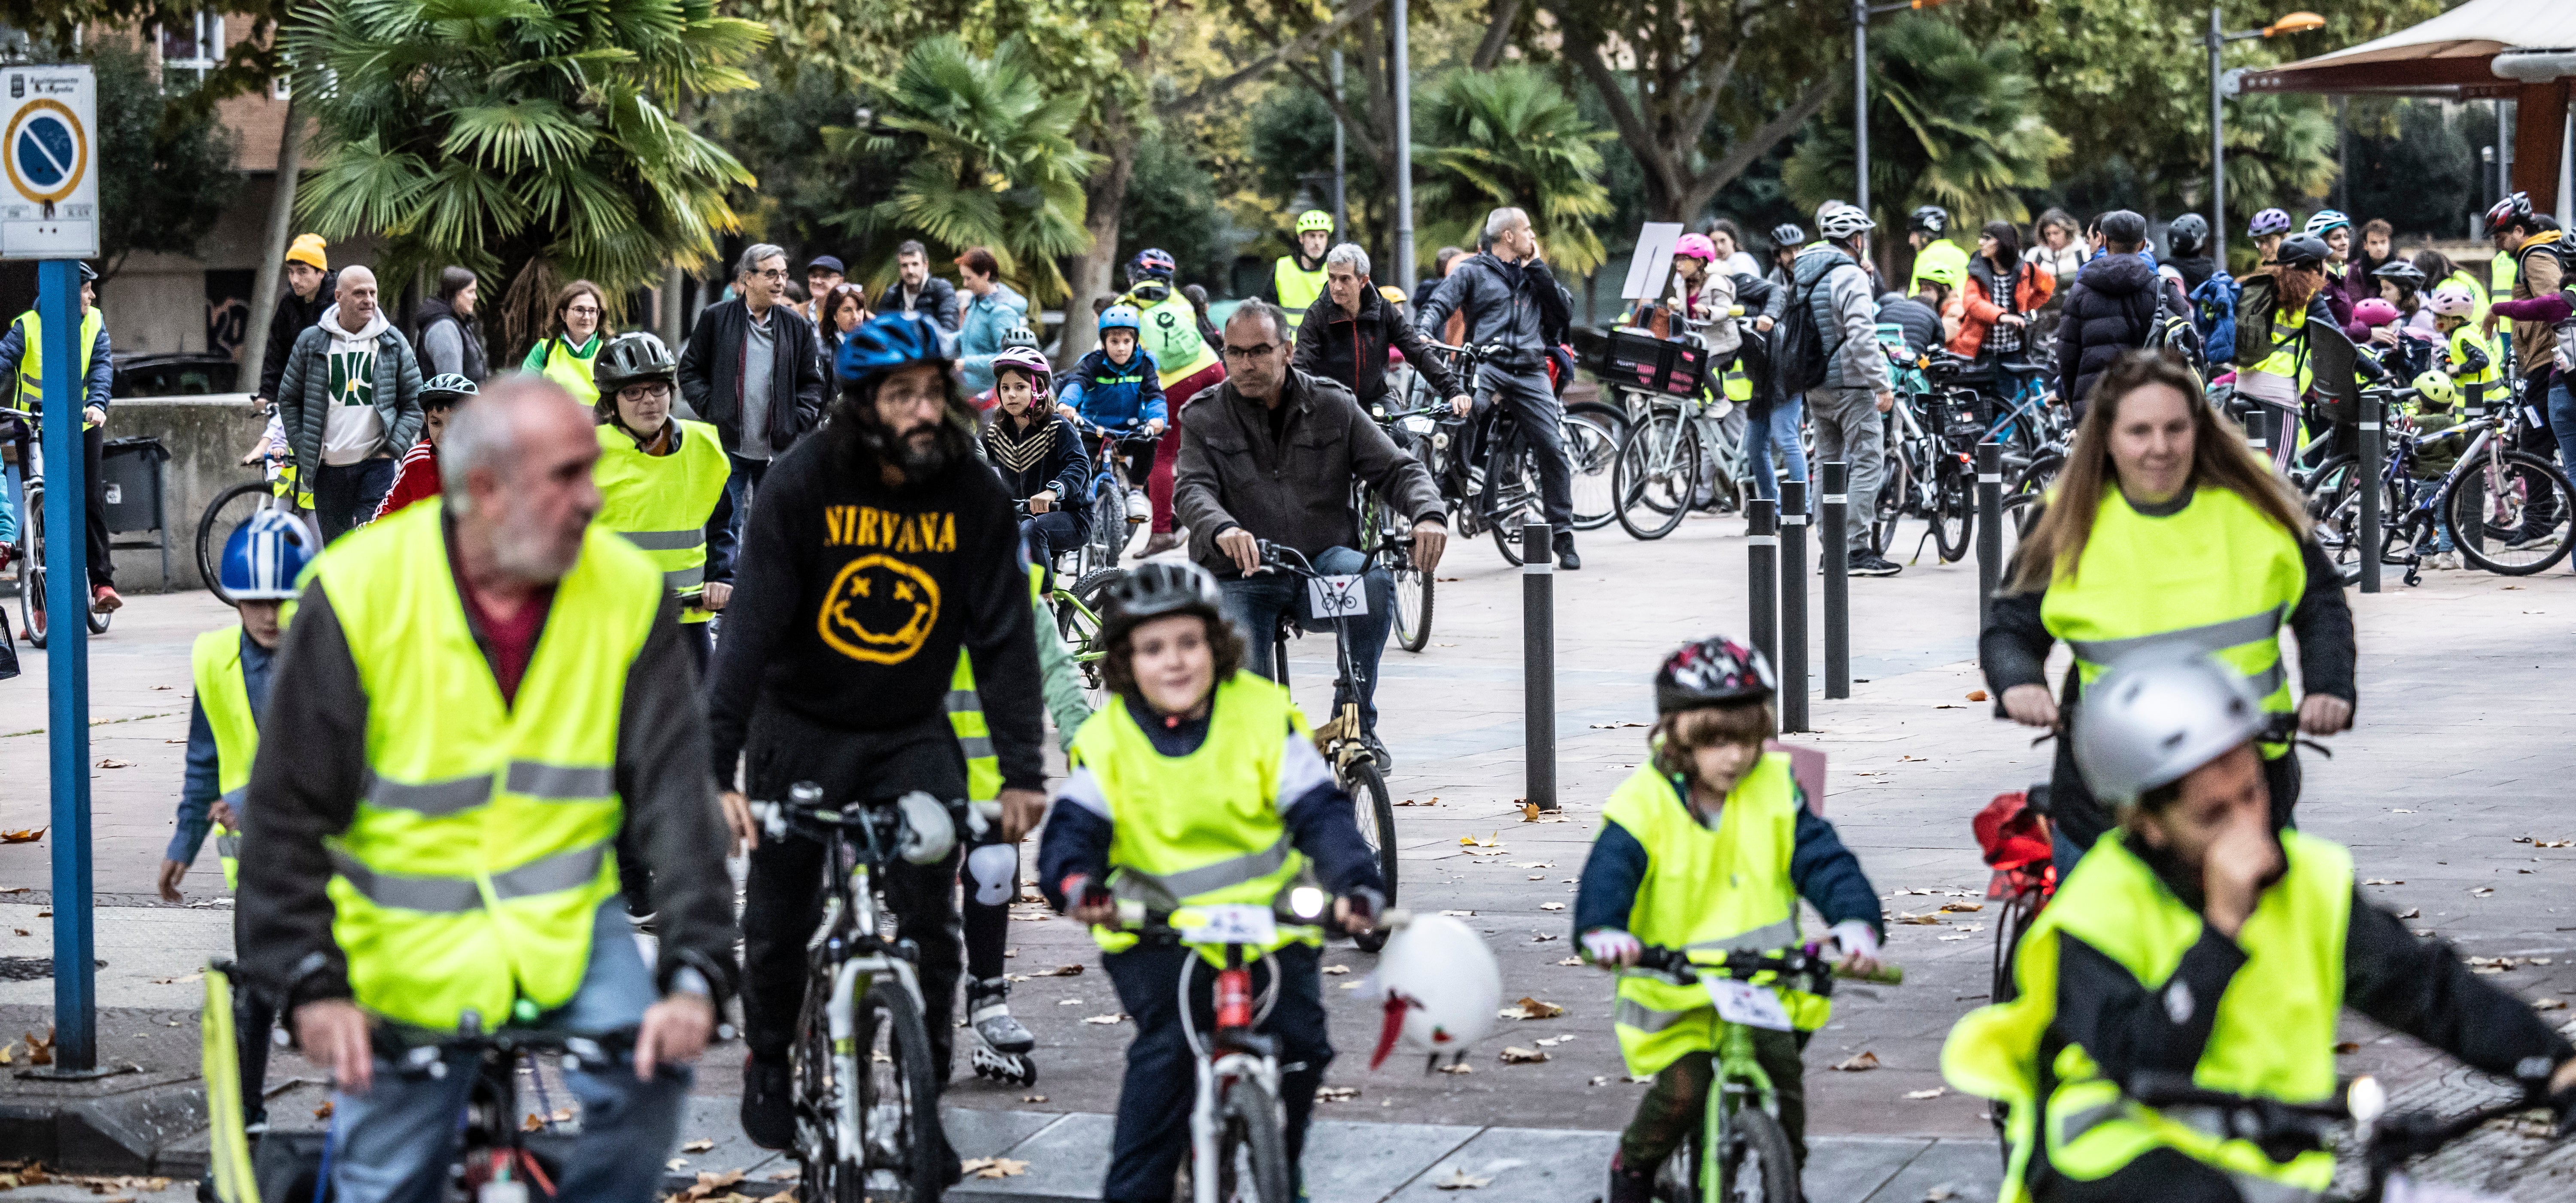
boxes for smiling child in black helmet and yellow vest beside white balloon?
[1038,559,1386,1203]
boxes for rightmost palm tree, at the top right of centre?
[1783,15,2066,242]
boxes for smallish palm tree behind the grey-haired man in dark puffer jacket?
[1399,64,1615,283]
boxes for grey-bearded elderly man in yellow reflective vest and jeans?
[240,376,734,1203]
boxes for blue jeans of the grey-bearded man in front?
[330,899,690,1203]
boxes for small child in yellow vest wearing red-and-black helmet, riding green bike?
[1574,636,1886,1203]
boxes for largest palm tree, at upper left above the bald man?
[286,0,770,358]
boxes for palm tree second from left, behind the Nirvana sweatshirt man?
[822,36,1100,304]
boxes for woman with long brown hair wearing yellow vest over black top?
[1978,350,2354,878]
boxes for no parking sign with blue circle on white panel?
[0,67,98,260]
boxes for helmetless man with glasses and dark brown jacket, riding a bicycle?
[1172,299,1448,770]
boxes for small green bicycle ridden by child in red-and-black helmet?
[1636,945,1906,1203]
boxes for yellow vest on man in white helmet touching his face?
[1940,829,2352,1203]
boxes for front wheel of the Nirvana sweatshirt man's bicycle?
[858,976,956,1203]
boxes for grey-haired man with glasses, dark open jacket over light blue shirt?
[680,242,827,567]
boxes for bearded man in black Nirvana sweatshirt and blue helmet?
[708,314,1046,1170]
